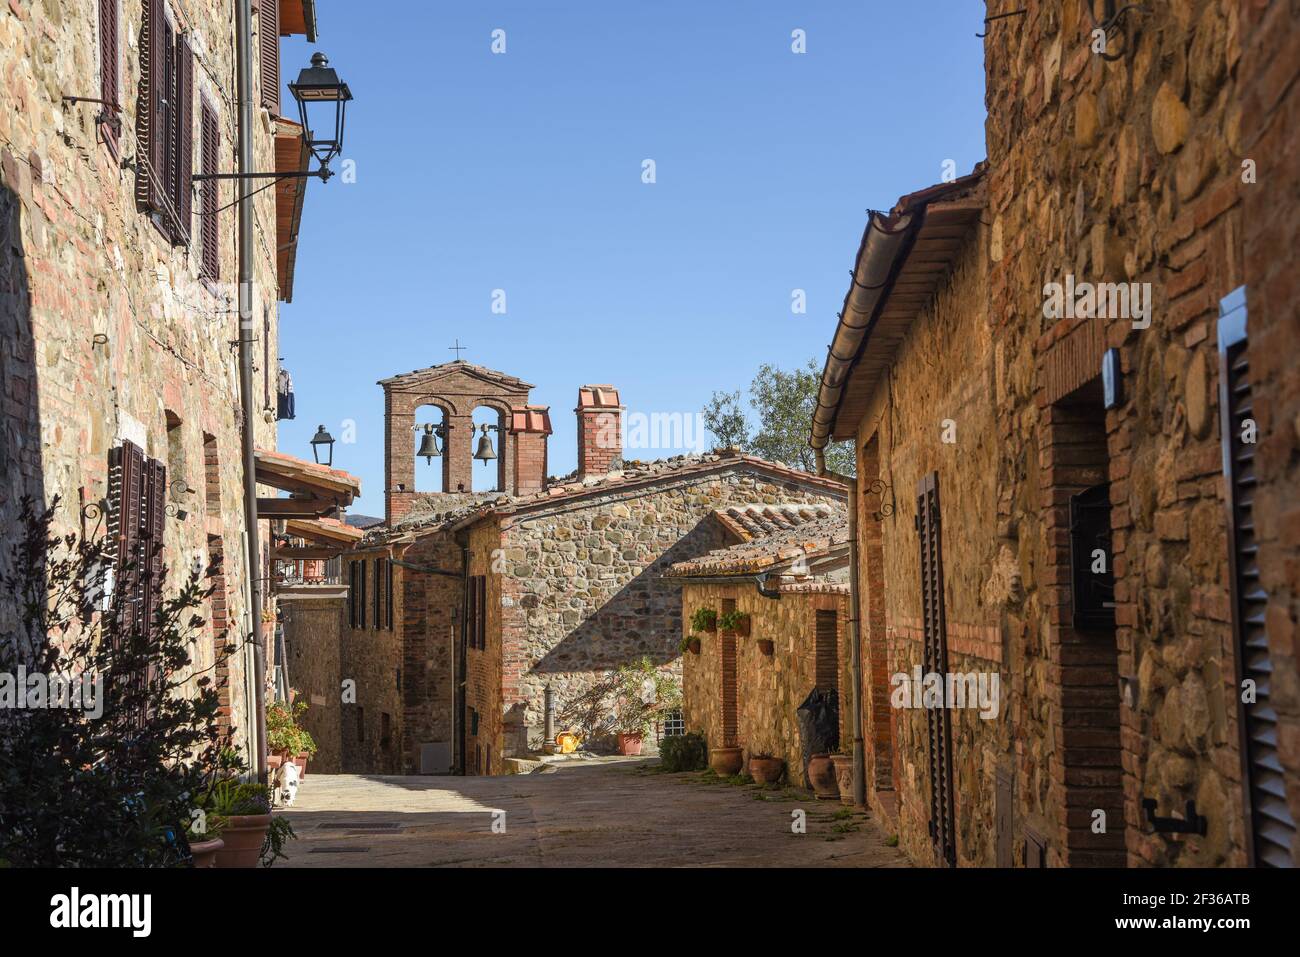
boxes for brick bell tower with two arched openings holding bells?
[380,359,551,525]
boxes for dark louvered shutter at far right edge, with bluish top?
[1218,289,1296,867]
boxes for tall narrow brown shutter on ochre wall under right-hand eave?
[915,472,957,865]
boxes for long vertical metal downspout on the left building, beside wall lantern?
[235,0,267,784]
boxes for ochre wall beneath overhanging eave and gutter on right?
[855,228,1008,865]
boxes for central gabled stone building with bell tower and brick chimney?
[290,361,844,774]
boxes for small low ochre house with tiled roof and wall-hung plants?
[667,506,853,787]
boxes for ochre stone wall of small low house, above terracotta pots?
[680,580,853,787]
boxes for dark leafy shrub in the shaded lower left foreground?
[0,499,242,867]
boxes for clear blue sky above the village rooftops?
[280,0,984,515]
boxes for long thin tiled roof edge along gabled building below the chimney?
[367,450,846,544]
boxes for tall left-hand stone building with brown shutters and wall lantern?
[0,0,335,753]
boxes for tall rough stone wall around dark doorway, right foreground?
[985,0,1252,865]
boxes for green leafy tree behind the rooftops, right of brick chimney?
[703,359,857,475]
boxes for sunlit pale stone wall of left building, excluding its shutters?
[0,0,289,753]
